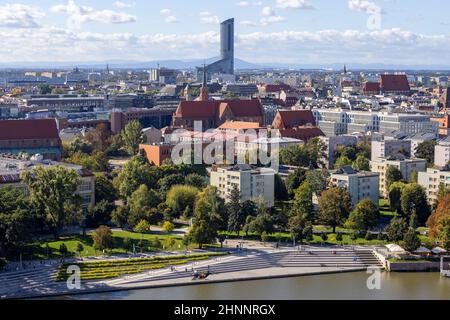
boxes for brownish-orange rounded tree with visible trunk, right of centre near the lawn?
[319,188,352,233]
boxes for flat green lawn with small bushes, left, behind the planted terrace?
[22,231,190,260]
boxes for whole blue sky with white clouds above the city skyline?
[0,0,450,66]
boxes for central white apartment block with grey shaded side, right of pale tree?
[210,165,275,208]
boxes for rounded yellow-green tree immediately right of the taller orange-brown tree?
[346,199,380,231]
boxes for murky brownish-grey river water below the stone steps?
[71,272,450,300]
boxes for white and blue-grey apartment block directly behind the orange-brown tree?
[330,167,380,206]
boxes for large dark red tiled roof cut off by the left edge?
[0,119,59,140]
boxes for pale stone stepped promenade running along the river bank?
[0,247,381,298]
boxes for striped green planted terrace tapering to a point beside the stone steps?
[56,253,227,281]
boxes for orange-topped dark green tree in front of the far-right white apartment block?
[400,183,431,225]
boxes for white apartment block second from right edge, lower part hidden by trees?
[370,157,427,197]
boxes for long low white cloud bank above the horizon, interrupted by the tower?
[0,27,450,66]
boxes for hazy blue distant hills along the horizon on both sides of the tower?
[0,58,450,71]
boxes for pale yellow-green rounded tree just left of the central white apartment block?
[166,185,199,217]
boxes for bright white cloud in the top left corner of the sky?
[0,3,45,28]
